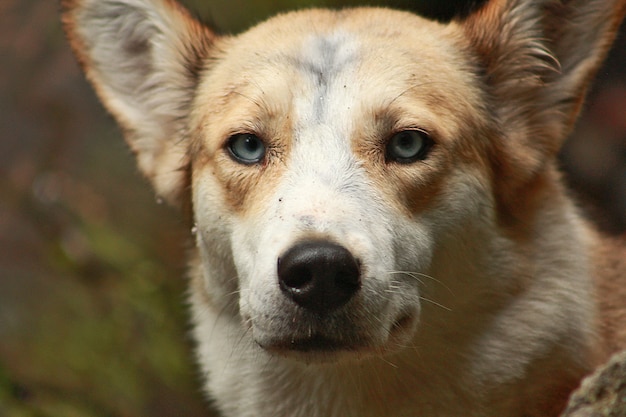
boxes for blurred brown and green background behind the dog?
[0,0,626,417]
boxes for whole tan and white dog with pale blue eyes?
[62,0,626,417]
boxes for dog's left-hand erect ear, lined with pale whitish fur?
[62,0,215,205]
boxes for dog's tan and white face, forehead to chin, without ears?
[191,10,492,356]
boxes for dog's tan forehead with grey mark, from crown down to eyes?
[197,8,475,150]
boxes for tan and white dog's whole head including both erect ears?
[64,0,624,358]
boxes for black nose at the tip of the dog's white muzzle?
[278,240,361,313]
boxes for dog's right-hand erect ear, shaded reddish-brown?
[460,0,626,181]
